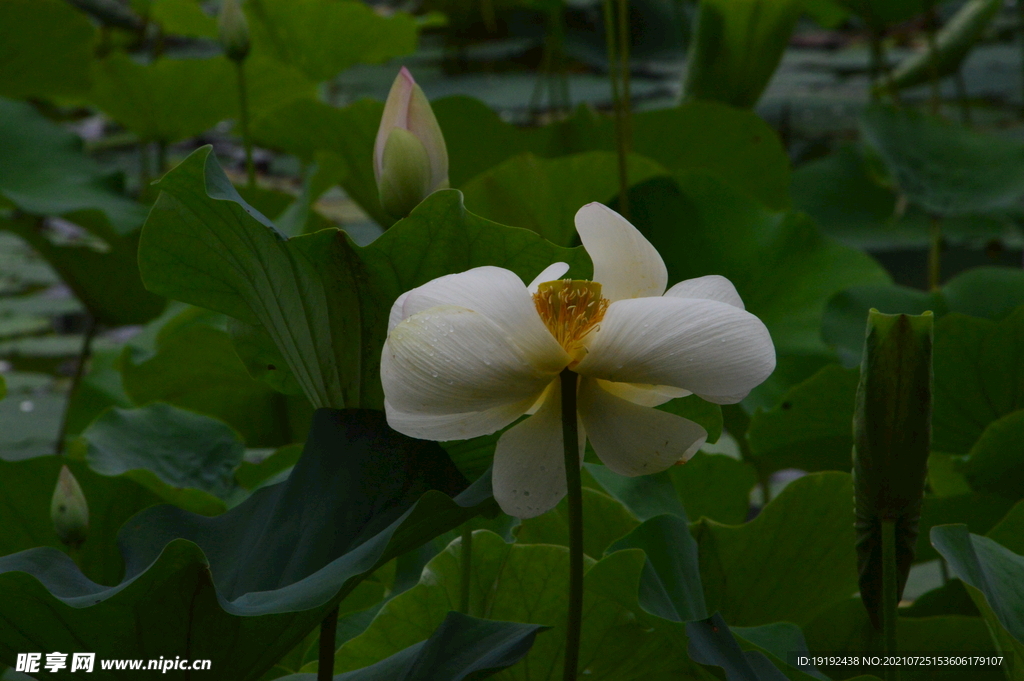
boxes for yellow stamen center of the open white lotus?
[534,280,608,367]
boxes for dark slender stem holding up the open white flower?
[561,369,583,681]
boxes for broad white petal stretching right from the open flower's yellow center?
[575,297,775,396]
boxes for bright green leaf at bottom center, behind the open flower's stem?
[335,531,711,681]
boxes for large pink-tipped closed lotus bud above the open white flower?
[374,68,449,219]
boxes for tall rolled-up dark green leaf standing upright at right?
[853,309,934,629]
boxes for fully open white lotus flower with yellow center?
[381,204,775,518]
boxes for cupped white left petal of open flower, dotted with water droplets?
[381,305,557,415]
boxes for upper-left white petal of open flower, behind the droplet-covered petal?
[391,266,569,372]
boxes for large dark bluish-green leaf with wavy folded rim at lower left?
[0,411,493,681]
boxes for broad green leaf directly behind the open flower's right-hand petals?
[630,175,889,354]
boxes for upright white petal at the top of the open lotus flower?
[575,203,669,301]
